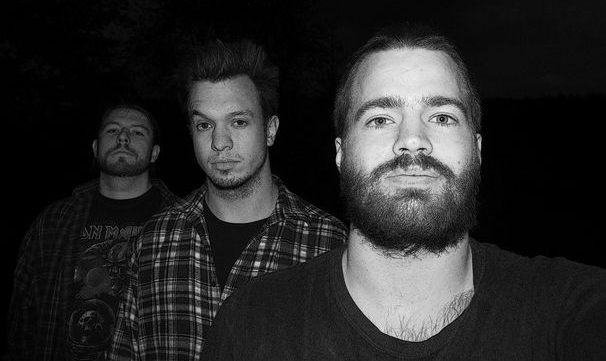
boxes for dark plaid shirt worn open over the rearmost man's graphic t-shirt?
[8,179,177,361]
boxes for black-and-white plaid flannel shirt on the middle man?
[109,176,347,361]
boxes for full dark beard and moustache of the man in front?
[341,153,480,257]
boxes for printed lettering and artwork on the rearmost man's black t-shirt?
[68,225,142,360]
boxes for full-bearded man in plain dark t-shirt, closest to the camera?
[204,24,606,360]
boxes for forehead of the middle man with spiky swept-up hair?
[189,75,260,114]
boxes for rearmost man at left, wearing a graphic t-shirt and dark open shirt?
[8,104,177,361]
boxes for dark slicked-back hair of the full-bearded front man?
[333,23,482,137]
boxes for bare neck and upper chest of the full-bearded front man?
[343,229,473,341]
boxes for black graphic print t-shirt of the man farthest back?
[67,187,162,360]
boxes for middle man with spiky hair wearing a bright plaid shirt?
[109,40,347,360]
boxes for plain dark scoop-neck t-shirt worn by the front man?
[203,241,606,361]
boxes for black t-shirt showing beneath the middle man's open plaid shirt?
[204,201,267,287]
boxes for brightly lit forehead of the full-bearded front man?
[352,48,462,105]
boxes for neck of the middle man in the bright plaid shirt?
[206,170,279,223]
